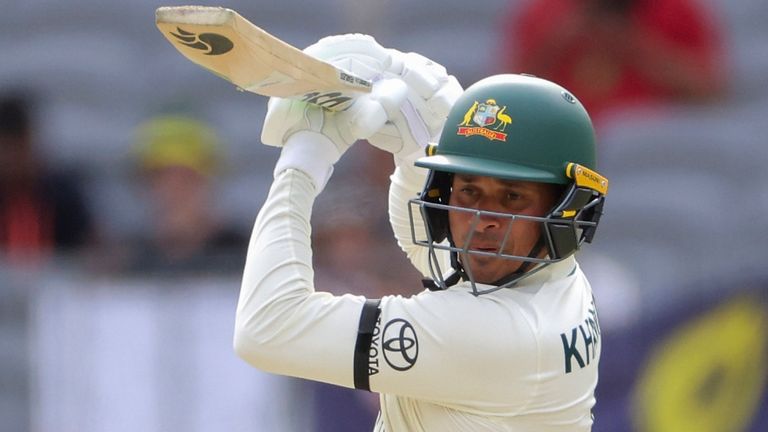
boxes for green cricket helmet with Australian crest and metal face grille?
[410,74,608,294]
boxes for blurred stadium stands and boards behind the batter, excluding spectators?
[0,0,768,432]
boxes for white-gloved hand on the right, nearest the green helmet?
[368,49,464,165]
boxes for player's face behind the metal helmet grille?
[448,174,556,283]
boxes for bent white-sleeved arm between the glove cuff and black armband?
[234,169,364,386]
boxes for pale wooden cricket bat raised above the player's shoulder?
[155,6,372,111]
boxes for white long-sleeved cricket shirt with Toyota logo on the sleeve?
[235,168,600,432]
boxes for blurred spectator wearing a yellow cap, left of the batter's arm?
[129,115,247,273]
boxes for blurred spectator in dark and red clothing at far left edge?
[0,94,95,262]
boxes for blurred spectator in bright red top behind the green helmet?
[503,0,724,122]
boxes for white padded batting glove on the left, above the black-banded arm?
[261,34,408,190]
